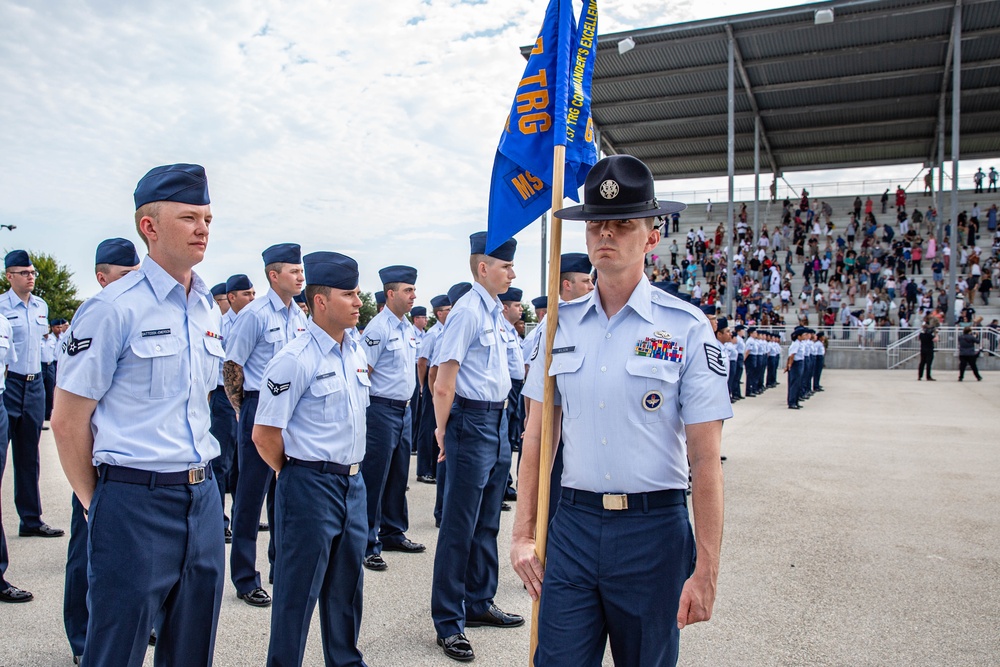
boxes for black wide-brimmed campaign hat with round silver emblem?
[552,155,687,220]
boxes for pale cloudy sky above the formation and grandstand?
[0,0,888,304]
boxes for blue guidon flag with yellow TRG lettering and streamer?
[486,0,597,253]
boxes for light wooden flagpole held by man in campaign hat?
[528,146,566,667]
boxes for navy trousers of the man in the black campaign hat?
[535,491,695,667]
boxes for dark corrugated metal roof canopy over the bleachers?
[525,0,1000,180]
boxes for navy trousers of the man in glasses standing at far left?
[3,374,45,529]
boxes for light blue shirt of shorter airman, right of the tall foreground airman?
[254,322,371,465]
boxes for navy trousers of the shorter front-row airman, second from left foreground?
[267,462,368,667]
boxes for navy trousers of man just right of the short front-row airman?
[361,403,411,556]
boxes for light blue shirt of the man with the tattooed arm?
[226,290,308,391]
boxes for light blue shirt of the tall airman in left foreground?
[57,257,224,472]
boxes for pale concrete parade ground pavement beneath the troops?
[0,370,1000,667]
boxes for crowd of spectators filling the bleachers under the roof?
[647,181,1000,346]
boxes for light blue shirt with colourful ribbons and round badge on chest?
[522,280,733,493]
